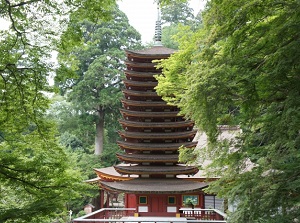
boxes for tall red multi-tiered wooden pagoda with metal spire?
[95,2,208,216]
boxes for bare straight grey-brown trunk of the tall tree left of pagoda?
[95,107,104,155]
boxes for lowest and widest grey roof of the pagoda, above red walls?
[100,179,208,194]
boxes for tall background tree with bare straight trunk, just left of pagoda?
[56,8,140,155]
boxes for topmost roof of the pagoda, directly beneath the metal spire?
[125,46,176,58]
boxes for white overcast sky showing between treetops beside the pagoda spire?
[119,0,206,43]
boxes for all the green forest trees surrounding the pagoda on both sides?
[0,0,300,223]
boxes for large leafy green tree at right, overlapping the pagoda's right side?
[157,0,300,222]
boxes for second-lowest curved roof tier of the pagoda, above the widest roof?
[114,165,199,175]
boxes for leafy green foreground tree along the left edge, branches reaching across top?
[0,0,114,222]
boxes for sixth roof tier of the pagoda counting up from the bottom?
[119,120,194,128]
